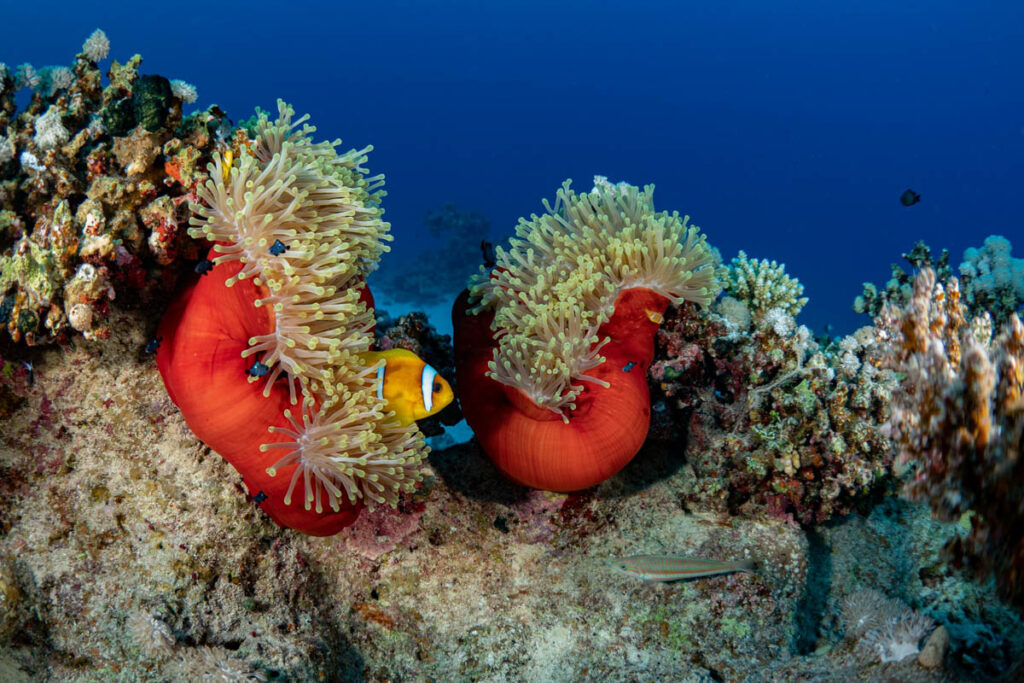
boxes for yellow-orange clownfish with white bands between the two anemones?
[359,348,455,425]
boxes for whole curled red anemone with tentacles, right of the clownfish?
[453,177,716,490]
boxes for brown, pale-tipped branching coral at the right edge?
[878,268,1024,604]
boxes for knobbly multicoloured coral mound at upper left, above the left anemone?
[0,31,223,346]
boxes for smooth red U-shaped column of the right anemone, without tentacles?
[452,288,669,492]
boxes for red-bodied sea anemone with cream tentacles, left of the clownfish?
[157,102,428,536]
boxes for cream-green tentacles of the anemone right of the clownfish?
[470,176,716,419]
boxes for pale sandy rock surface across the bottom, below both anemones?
[0,308,1022,681]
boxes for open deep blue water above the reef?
[0,0,1024,332]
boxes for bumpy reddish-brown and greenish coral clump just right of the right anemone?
[649,299,894,524]
